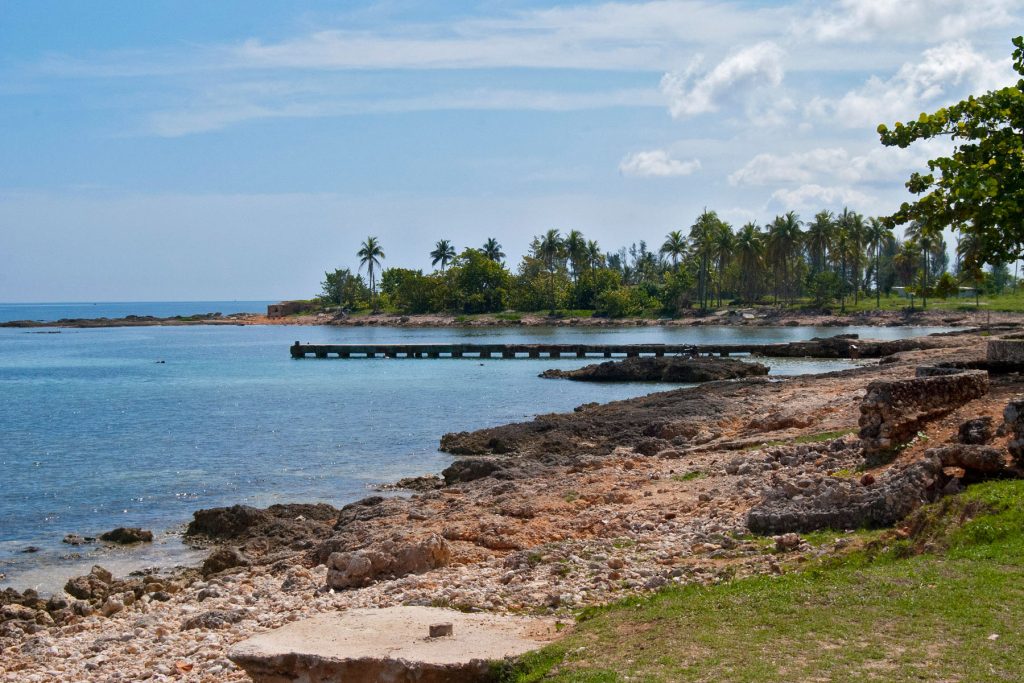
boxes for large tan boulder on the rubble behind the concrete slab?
[327,533,452,590]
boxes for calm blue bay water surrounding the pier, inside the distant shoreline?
[0,327,950,590]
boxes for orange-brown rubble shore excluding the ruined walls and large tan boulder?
[0,325,1020,681]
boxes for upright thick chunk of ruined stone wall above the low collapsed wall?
[860,368,988,454]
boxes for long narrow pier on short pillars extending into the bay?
[291,342,776,358]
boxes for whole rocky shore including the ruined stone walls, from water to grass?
[0,325,1024,682]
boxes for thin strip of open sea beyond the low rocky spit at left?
[0,301,276,323]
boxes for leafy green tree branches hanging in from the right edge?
[878,36,1024,269]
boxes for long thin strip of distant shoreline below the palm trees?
[0,308,1022,329]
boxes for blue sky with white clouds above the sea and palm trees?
[0,0,1024,302]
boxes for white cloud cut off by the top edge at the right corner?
[795,0,1020,43]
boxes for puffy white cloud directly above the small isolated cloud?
[662,41,785,119]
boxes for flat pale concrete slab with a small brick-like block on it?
[228,607,557,683]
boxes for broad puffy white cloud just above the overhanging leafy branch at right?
[807,40,1015,129]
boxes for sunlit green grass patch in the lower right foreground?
[500,481,1024,683]
